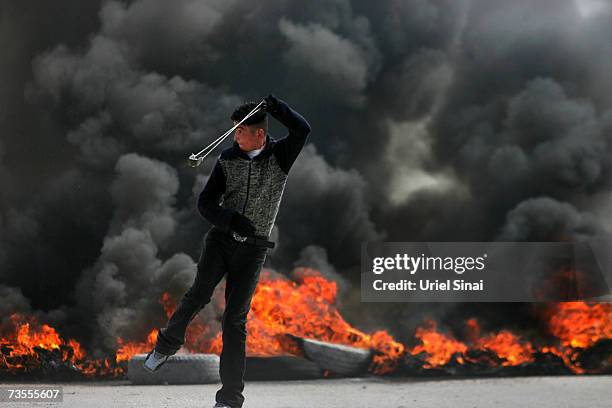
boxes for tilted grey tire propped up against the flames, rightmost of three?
[296,338,372,376]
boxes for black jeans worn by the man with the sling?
[155,228,267,407]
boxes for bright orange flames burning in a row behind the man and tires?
[0,268,612,378]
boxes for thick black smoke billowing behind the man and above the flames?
[0,0,612,351]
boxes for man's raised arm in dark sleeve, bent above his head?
[266,95,310,174]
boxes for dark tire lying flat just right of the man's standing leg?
[245,356,323,381]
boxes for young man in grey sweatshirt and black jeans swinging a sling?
[144,95,310,408]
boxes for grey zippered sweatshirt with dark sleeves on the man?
[198,99,310,238]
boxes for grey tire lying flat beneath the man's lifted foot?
[128,354,220,384]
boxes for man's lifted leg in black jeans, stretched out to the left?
[155,237,228,355]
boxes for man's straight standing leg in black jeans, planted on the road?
[216,245,267,407]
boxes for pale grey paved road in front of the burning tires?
[0,376,612,408]
